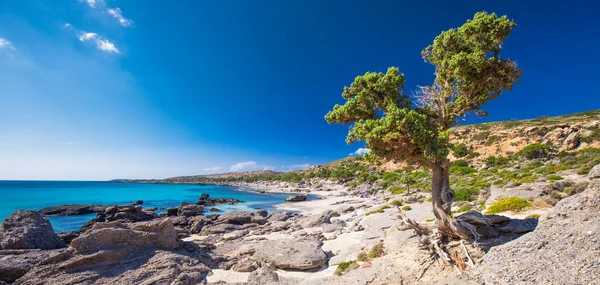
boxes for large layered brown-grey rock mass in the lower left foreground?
[14,219,210,285]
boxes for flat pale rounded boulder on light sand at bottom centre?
[252,236,327,270]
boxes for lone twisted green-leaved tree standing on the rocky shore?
[325,12,522,239]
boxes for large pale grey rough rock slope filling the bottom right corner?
[474,180,600,284]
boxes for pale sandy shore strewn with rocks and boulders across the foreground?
[0,172,600,284]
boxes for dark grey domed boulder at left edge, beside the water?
[0,210,66,249]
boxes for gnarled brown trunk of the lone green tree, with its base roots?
[431,161,477,240]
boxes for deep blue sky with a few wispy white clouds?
[0,0,600,180]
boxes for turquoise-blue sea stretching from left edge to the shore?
[0,181,300,232]
